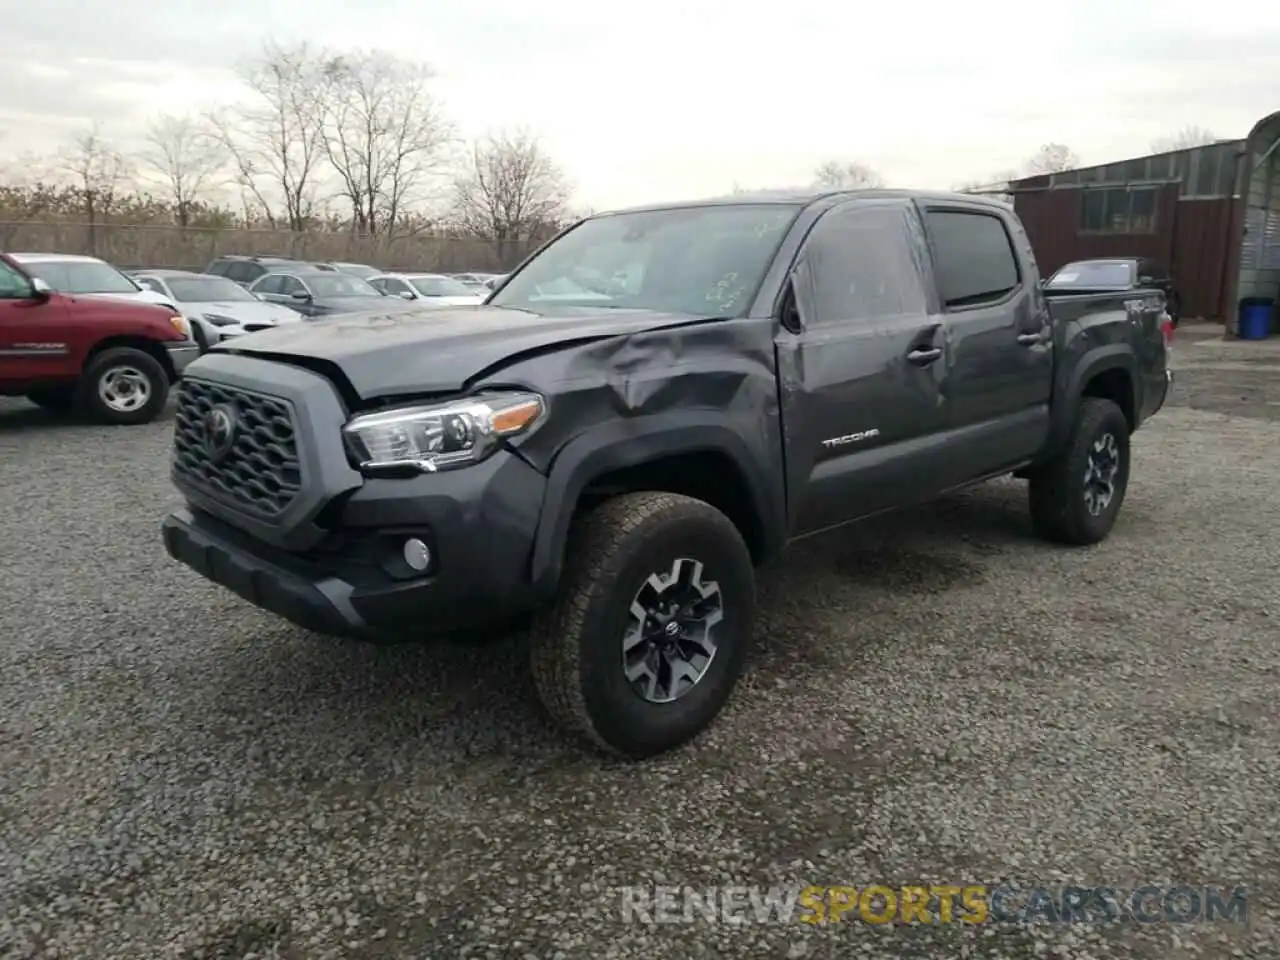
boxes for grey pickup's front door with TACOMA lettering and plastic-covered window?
[776,200,946,536]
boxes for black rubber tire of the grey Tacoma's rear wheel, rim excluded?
[1028,397,1130,547]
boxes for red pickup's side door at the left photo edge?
[0,260,79,388]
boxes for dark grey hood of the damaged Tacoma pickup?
[216,307,721,399]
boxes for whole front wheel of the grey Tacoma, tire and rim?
[531,493,755,759]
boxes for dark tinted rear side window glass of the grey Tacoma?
[925,210,1021,307]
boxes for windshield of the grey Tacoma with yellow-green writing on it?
[489,204,800,316]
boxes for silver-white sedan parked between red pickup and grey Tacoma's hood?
[133,270,301,353]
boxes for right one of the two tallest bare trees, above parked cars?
[324,51,453,236]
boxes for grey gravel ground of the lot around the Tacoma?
[0,348,1280,960]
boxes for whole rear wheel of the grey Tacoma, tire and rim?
[1029,397,1129,547]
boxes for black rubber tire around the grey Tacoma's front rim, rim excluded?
[530,493,755,759]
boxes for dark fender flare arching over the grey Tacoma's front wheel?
[530,411,786,596]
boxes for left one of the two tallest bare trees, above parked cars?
[209,44,332,232]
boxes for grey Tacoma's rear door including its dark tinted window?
[923,201,1053,486]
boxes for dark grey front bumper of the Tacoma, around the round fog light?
[163,453,545,639]
